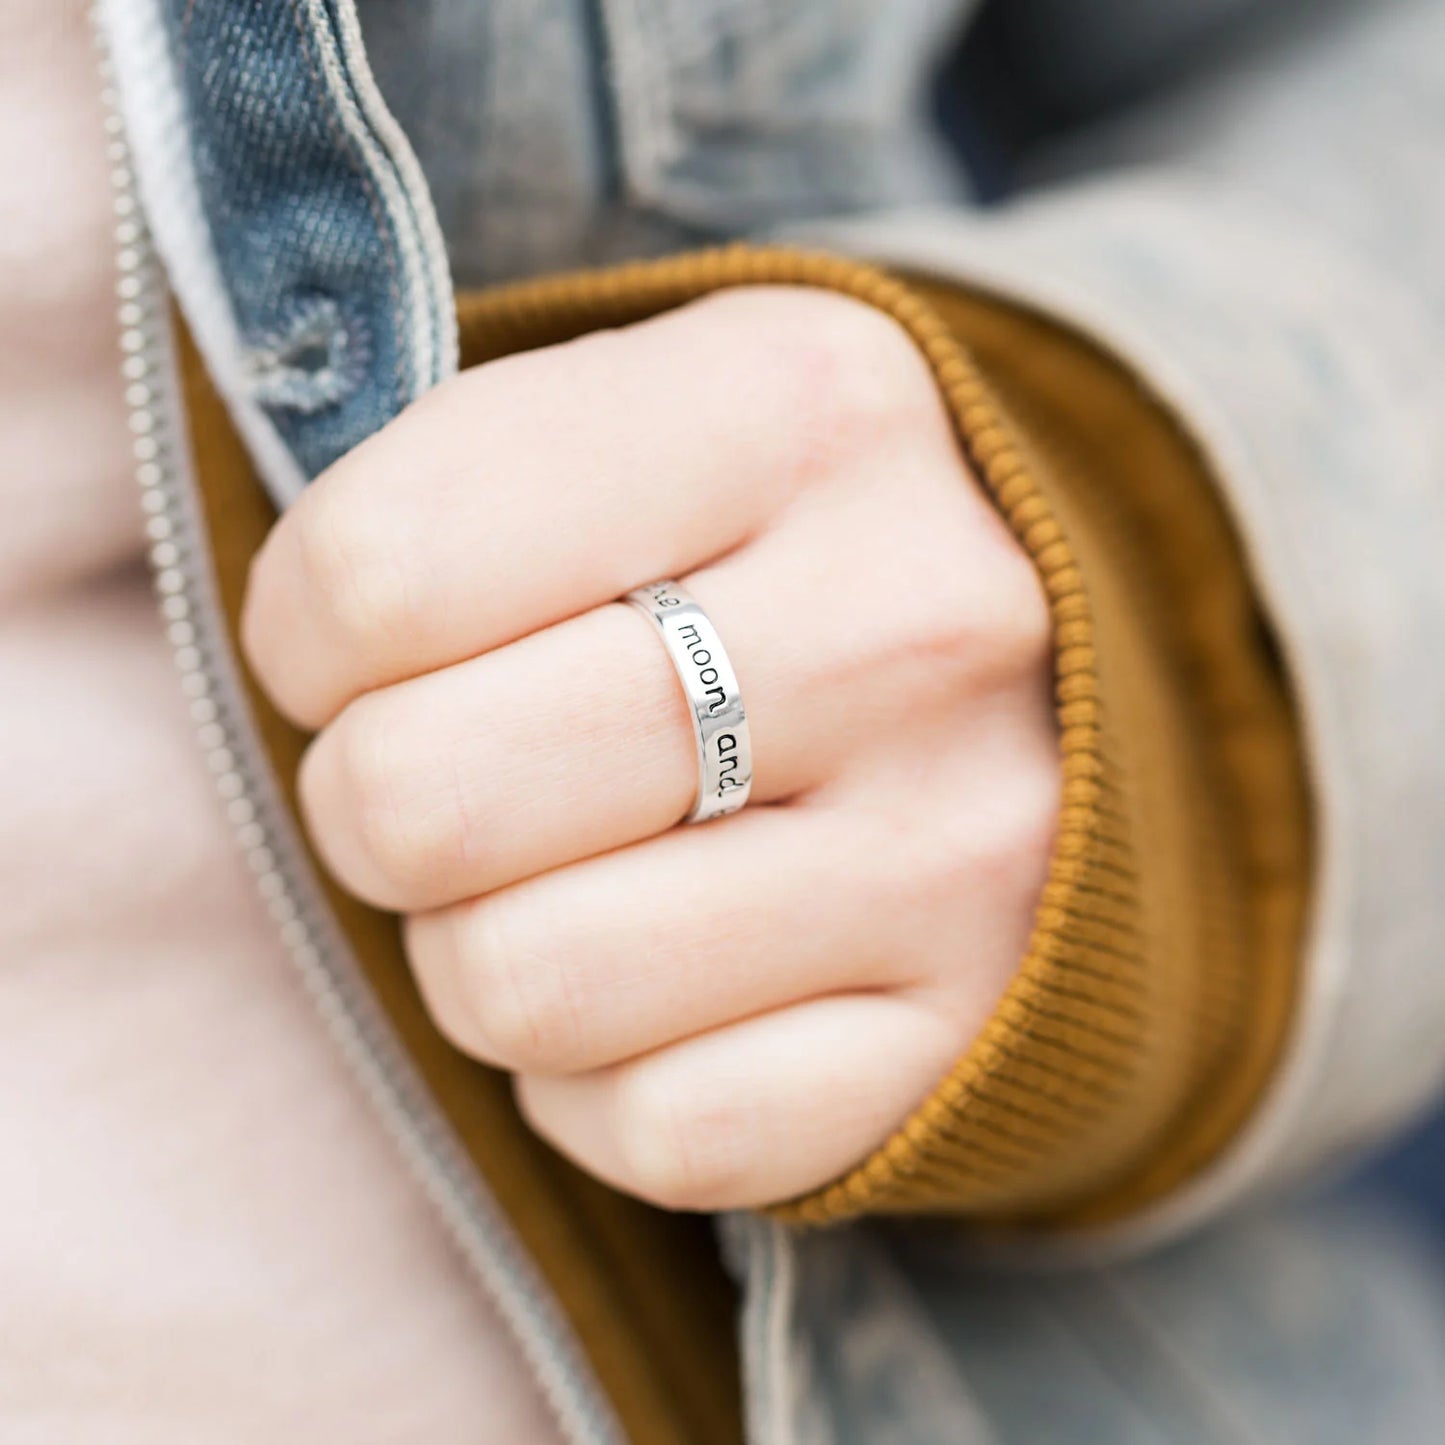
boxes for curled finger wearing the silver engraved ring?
[301,511,860,912]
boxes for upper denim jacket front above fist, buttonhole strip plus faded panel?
[135,0,975,488]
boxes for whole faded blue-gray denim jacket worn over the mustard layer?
[98,0,1445,1445]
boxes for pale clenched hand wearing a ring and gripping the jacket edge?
[243,288,1059,1209]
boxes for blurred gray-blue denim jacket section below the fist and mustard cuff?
[728,1192,1445,1445]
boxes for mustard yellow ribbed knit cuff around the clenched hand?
[439,246,1309,1222]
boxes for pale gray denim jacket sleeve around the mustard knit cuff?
[809,0,1445,1234]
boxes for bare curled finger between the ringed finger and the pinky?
[406,808,922,1074]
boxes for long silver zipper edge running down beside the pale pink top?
[95,25,624,1445]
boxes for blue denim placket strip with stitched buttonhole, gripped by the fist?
[151,0,451,475]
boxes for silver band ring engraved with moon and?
[623,582,753,822]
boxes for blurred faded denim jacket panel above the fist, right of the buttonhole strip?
[357,0,977,285]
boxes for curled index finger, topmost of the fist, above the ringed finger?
[234,288,919,727]
